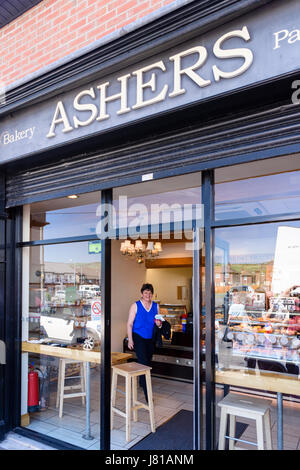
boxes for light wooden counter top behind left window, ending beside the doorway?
[22,341,132,365]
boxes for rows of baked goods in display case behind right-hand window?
[217,293,300,374]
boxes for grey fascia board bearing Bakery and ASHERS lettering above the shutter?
[0,0,300,161]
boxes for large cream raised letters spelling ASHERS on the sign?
[47,26,253,138]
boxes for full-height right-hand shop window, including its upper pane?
[214,155,300,449]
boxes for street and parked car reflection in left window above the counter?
[29,241,101,344]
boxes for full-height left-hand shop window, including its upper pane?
[21,193,103,450]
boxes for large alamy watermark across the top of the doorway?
[96,196,204,250]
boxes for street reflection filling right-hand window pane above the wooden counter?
[215,222,300,374]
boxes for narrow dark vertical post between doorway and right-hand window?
[202,170,216,450]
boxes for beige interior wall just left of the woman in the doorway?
[111,240,146,352]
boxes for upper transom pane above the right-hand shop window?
[215,154,300,220]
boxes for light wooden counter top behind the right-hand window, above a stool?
[215,370,300,395]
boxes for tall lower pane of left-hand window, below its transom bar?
[21,241,101,449]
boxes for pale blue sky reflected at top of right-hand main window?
[215,222,300,264]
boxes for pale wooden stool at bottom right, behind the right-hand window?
[218,393,272,450]
